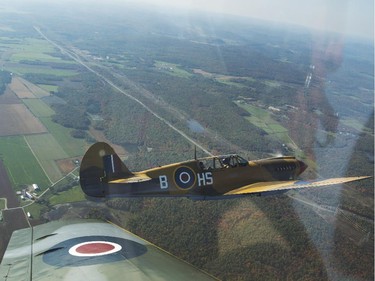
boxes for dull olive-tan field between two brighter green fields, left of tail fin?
[25,134,68,182]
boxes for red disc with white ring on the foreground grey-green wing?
[69,241,122,257]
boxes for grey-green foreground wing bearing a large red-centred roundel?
[0,220,216,281]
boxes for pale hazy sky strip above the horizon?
[0,0,374,41]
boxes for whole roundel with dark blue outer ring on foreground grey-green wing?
[43,236,147,267]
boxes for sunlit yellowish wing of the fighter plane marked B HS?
[224,176,370,195]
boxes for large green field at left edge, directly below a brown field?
[0,136,50,189]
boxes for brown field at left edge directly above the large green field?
[0,104,47,136]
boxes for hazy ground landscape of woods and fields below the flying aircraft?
[0,1,374,280]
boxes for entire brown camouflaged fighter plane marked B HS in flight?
[80,142,368,200]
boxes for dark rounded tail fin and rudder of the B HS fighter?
[79,142,133,197]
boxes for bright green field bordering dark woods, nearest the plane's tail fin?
[39,117,86,157]
